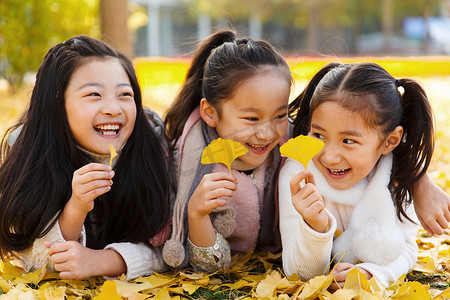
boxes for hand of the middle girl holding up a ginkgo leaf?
[188,172,237,219]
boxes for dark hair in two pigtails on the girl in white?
[289,62,435,219]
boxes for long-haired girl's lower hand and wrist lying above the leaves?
[45,241,126,279]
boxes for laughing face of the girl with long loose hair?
[64,58,136,154]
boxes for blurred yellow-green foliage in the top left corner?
[0,0,100,90]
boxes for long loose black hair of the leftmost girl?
[0,36,173,254]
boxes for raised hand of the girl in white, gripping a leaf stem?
[290,170,328,233]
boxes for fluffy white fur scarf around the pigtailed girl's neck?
[309,154,405,265]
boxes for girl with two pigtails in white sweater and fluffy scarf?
[279,63,434,289]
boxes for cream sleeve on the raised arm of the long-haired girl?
[10,221,86,272]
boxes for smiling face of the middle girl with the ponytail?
[200,70,290,170]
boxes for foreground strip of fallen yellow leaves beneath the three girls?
[0,230,450,300]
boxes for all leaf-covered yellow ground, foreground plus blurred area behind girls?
[0,60,450,300]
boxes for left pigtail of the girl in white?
[289,62,342,136]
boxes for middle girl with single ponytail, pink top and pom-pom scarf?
[163,31,292,271]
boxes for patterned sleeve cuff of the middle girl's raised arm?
[187,232,231,272]
